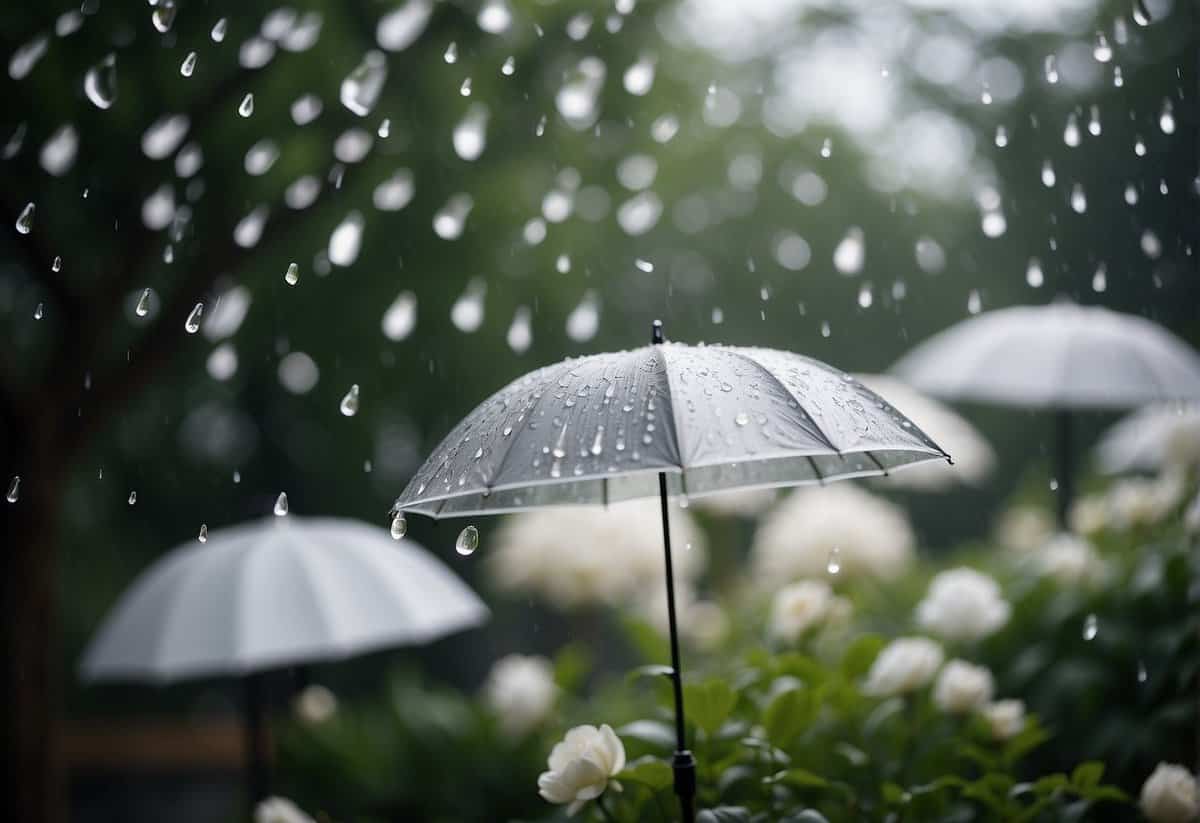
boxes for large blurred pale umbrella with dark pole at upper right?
[892,300,1200,525]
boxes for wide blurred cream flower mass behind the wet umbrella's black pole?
[488,500,704,609]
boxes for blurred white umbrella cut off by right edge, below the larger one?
[1096,403,1200,474]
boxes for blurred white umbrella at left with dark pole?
[80,516,487,820]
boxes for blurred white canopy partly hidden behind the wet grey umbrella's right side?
[857,374,996,492]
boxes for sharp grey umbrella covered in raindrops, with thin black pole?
[396,323,947,823]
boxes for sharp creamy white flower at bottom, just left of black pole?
[538,723,625,815]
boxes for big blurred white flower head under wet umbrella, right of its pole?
[751,483,914,585]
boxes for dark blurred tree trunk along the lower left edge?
[0,420,66,823]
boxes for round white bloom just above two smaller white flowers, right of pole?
[917,566,1012,641]
